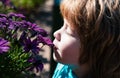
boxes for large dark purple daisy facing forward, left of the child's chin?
[23,38,40,54]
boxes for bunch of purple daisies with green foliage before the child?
[0,13,53,77]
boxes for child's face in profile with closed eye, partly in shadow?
[53,19,80,65]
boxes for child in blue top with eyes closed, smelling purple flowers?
[53,0,120,78]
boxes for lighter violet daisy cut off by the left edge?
[0,38,10,53]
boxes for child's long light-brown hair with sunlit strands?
[60,0,120,78]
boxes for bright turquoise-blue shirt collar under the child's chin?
[52,63,78,78]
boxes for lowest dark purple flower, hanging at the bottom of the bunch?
[28,58,44,72]
